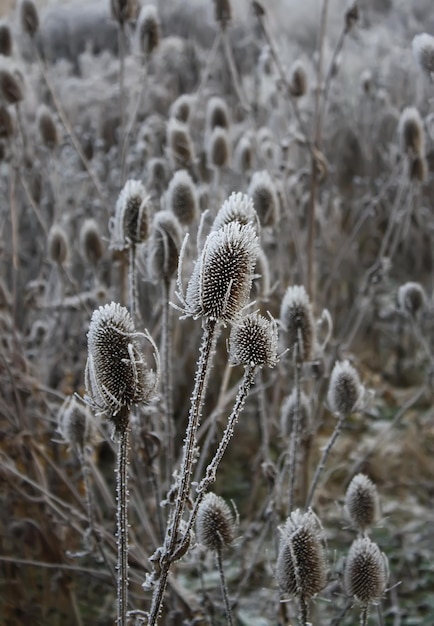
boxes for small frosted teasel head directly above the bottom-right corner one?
[345,474,380,532]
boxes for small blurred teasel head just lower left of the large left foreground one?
[57,396,91,453]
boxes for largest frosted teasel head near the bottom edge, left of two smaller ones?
[276,509,327,600]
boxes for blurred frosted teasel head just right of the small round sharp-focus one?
[280,285,315,361]
